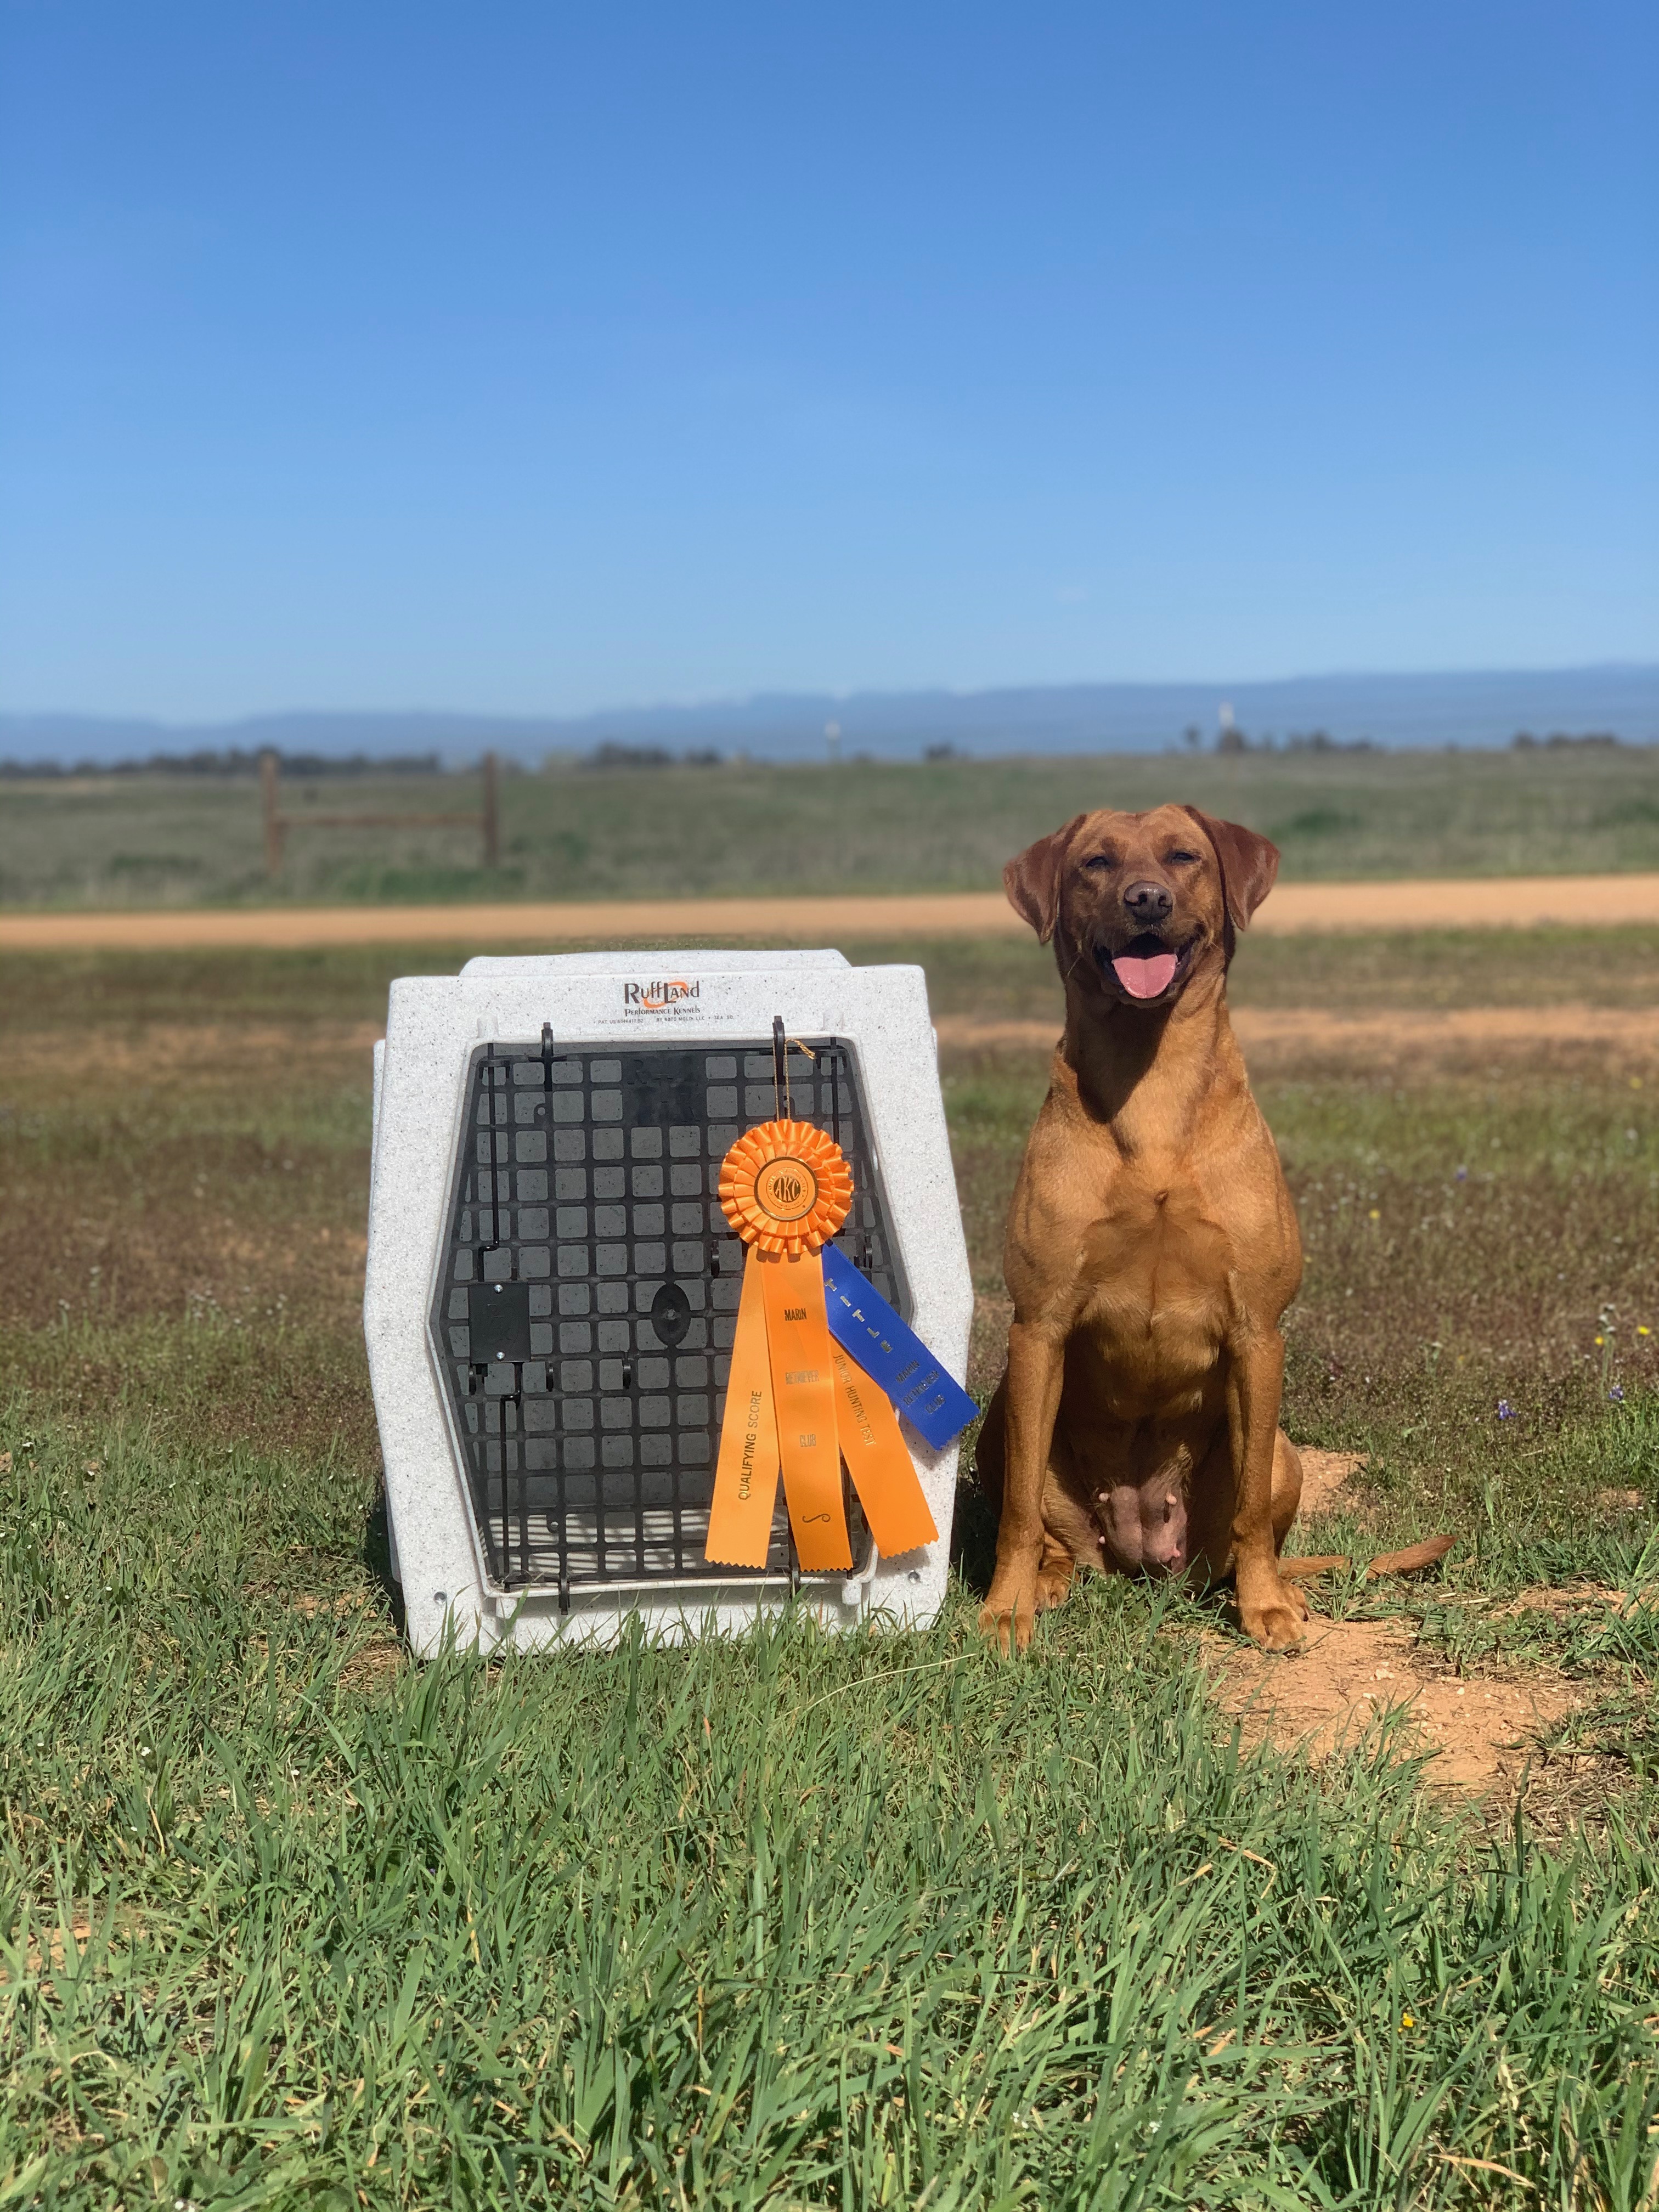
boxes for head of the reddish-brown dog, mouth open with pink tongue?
[1002,805,1278,1007]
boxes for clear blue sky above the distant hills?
[0,0,1659,719]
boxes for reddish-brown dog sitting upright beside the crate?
[978,805,1307,1650]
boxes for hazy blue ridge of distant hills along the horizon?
[0,662,1659,763]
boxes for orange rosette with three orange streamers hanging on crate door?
[703,1121,938,1573]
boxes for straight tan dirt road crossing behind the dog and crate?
[0,876,1659,951]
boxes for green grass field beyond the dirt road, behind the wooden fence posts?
[0,748,1659,907]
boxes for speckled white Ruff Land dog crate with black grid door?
[363,951,973,1652]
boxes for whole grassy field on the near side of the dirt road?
[0,924,1659,2212]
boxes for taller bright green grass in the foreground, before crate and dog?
[0,1425,1659,2208]
